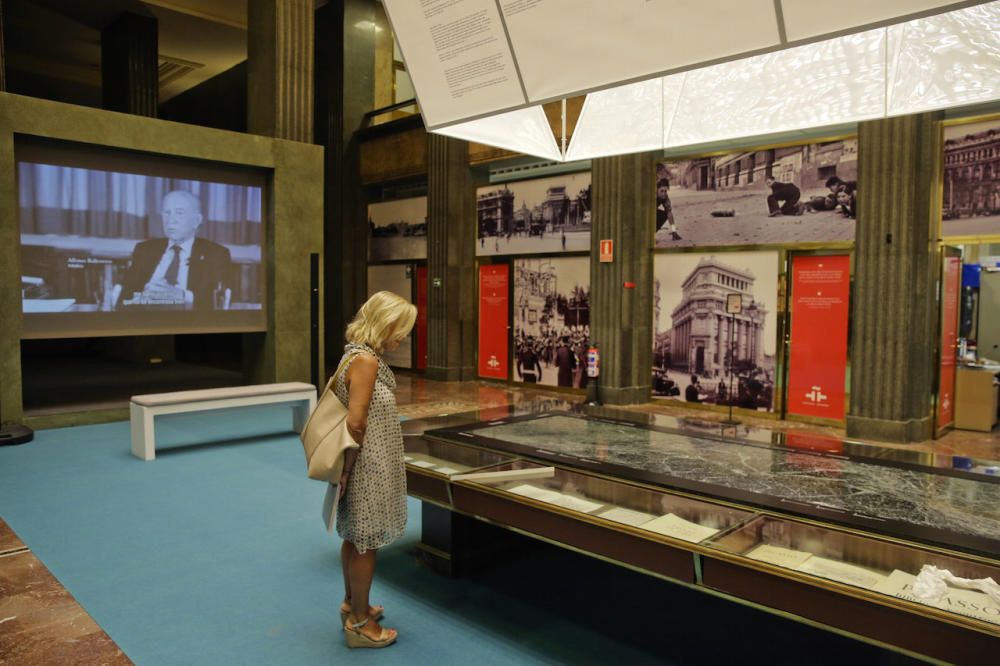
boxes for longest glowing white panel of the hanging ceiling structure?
[665,29,886,147]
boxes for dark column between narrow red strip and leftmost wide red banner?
[427,134,476,381]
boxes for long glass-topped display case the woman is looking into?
[407,412,1000,664]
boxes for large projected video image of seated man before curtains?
[18,160,264,314]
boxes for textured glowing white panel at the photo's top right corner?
[888,2,1000,115]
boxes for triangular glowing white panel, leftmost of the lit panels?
[431,106,563,161]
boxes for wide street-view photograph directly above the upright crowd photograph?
[476,171,590,256]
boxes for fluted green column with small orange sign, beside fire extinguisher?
[590,153,656,404]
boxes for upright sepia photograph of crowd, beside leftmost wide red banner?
[512,257,590,388]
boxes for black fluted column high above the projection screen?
[101,13,160,118]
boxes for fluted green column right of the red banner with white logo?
[847,113,942,442]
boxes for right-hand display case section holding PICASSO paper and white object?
[701,516,1000,664]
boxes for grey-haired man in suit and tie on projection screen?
[119,190,232,310]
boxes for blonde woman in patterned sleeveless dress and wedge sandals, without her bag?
[334,291,417,648]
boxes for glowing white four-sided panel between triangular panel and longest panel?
[566,78,664,162]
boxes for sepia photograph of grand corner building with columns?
[653,252,778,411]
